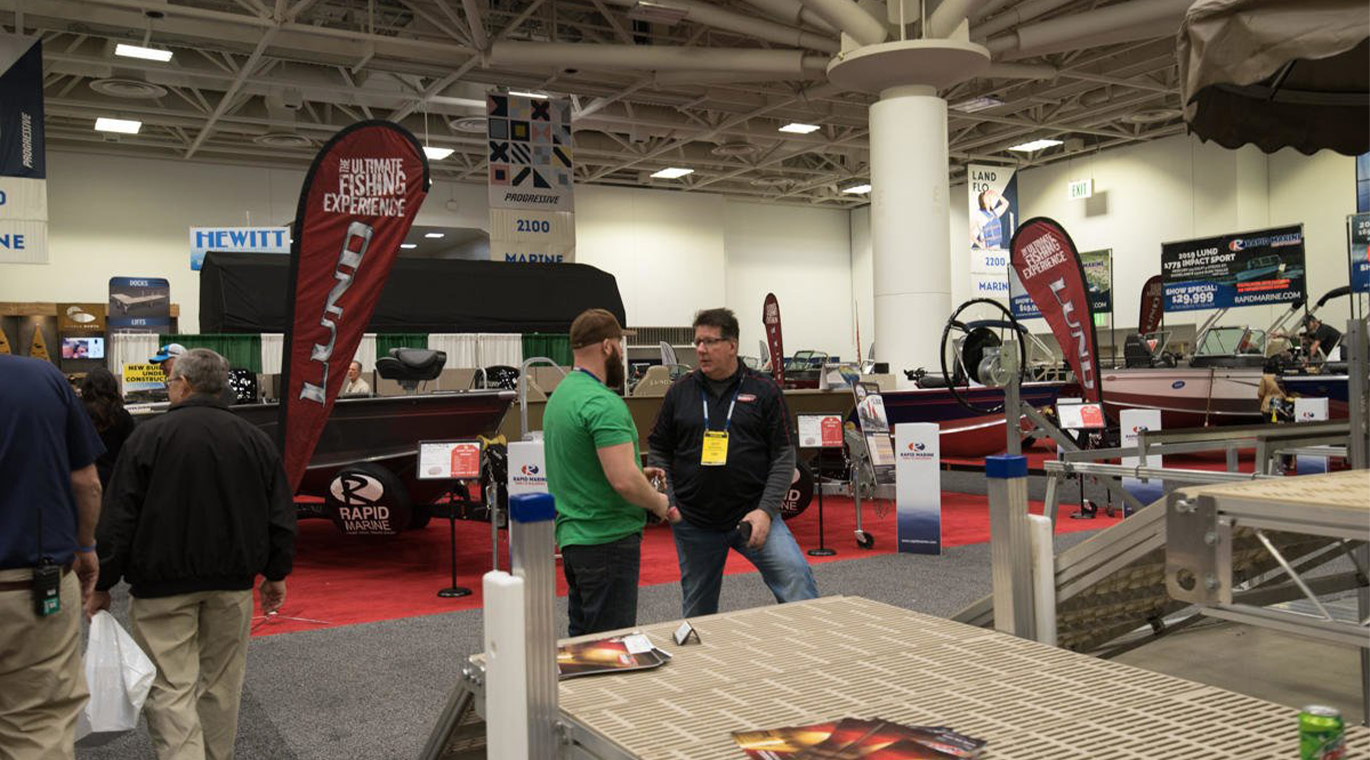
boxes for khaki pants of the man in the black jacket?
[129,592,252,760]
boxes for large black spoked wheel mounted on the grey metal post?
[941,299,1028,415]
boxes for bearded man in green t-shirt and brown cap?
[543,308,680,635]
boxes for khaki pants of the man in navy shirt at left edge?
[0,570,89,760]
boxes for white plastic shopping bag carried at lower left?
[77,609,158,746]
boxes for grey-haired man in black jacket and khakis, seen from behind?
[88,348,295,760]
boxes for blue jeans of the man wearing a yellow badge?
[671,518,818,618]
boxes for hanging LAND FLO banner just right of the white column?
[966,164,1018,300]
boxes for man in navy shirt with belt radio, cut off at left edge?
[0,355,104,760]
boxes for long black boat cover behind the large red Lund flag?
[200,252,627,334]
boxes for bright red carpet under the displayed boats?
[252,492,1118,635]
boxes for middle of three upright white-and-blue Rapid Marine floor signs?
[895,422,941,555]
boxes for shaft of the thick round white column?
[870,85,951,388]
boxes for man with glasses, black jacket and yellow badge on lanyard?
[648,308,818,618]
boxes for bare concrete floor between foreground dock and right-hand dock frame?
[1114,619,1365,724]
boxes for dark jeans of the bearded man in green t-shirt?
[562,533,643,635]
